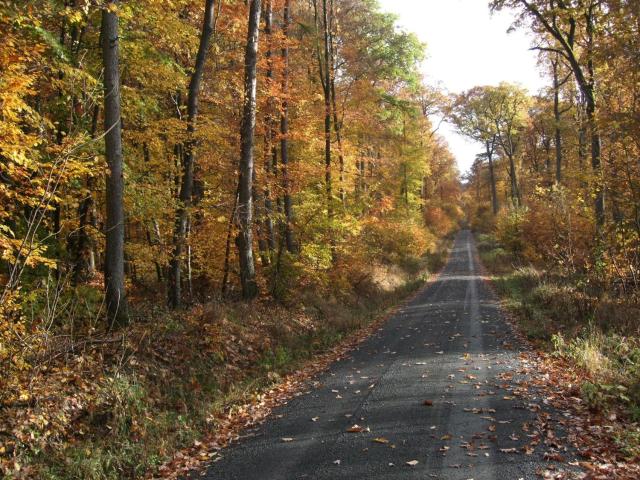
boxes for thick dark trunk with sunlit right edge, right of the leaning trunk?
[236,0,262,300]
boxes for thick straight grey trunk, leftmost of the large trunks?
[102,0,129,325]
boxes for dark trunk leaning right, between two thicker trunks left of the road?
[169,0,215,308]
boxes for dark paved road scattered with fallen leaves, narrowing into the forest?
[201,231,564,480]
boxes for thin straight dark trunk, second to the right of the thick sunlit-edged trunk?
[280,0,298,253]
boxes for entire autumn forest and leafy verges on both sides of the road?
[0,0,640,479]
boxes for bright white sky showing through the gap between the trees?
[378,0,545,172]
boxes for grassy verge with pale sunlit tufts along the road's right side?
[477,234,640,458]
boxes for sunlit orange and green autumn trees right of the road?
[460,0,640,292]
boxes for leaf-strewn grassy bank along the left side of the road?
[0,245,446,480]
